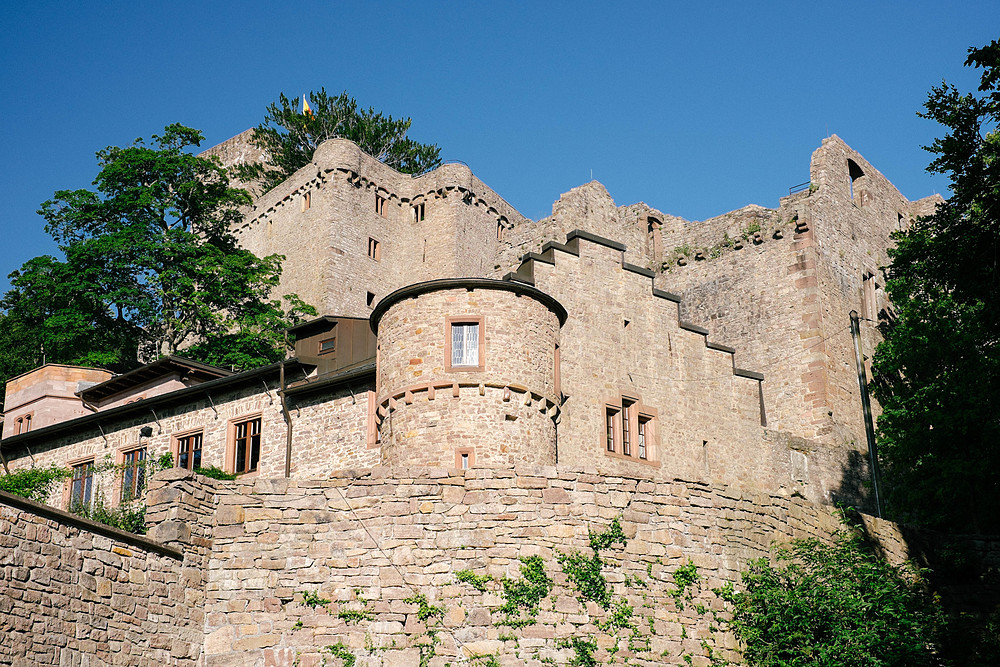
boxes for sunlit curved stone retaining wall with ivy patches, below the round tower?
[143,466,920,667]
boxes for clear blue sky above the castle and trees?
[0,0,1000,291]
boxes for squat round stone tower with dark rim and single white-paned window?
[371,278,566,468]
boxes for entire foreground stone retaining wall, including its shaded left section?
[0,466,1000,667]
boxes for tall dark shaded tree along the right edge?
[873,41,1000,532]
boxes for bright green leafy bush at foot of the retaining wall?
[718,527,944,667]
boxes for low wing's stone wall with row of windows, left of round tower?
[6,378,381,507]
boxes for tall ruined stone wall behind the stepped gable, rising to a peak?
[656,136,937,490]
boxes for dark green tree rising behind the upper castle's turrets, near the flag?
[236,88,441,192]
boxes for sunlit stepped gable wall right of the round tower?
[500,231,812,499]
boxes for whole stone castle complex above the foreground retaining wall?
[0,133,940,664]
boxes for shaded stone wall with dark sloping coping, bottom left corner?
[0,491,199,666]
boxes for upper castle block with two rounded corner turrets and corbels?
[234,139,524,317]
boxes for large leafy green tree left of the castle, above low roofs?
[0,124,315,388]
